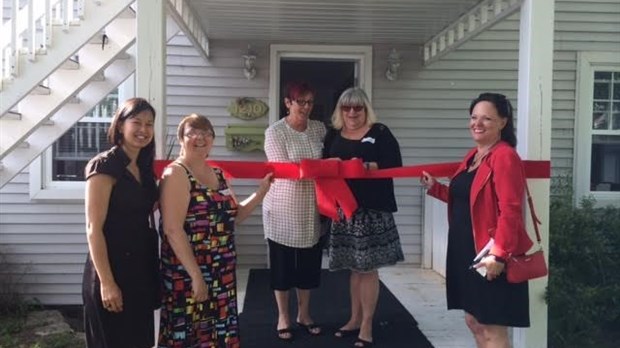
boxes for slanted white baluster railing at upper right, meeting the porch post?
[423,0,523,65]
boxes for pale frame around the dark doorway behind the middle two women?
[269,44,372,124]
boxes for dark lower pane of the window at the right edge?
[590,135,620,191]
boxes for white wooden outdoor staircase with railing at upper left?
[0,0,136,187]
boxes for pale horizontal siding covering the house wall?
[0,0,620,304]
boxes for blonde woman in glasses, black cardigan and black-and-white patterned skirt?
[324,88,404,347]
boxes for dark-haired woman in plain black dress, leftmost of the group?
[82,98,160,348]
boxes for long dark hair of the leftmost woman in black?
[108,98,155,186]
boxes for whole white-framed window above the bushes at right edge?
[575,53,620,204]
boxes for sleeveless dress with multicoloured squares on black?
[159,164,240,348]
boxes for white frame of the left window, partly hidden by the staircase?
[29,75,135,201]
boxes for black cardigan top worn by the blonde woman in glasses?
[323,123,403,212]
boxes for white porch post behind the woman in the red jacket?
[513,0,555,348]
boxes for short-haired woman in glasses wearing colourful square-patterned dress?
[158,114,272,348]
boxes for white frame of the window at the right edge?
[573,52,620,206]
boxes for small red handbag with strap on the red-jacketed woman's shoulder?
[506,183,549,283]
